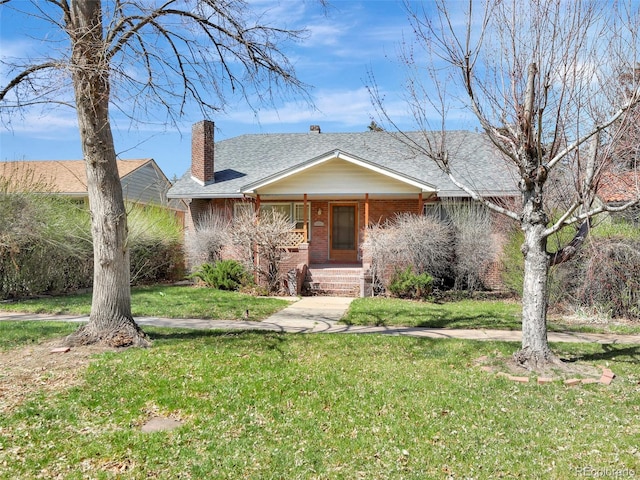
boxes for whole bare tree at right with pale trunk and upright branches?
[370,0,640,369]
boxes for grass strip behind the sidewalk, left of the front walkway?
[0,286,289,320]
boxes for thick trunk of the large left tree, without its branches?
[67,0,149,347]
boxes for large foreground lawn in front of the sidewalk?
[0,322,640,479]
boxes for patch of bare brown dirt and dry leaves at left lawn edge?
[0,339,117,414]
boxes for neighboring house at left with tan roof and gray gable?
[0,158,186,211]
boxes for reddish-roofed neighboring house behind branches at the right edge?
[596,170,640,225]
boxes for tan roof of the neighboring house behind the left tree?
[0,158,152,195]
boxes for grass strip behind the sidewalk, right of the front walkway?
[342,298,640,334]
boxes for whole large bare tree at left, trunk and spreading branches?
[0,0,305,346]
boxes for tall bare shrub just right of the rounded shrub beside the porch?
[444,202,498,291]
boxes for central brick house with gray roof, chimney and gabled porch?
[168,121,519,294]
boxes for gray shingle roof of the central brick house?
[168,131,518,198]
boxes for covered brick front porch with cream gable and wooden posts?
[242,151,436,266]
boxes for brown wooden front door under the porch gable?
[329,203,358,262]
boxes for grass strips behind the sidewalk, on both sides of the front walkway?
[0,286,640,334]
